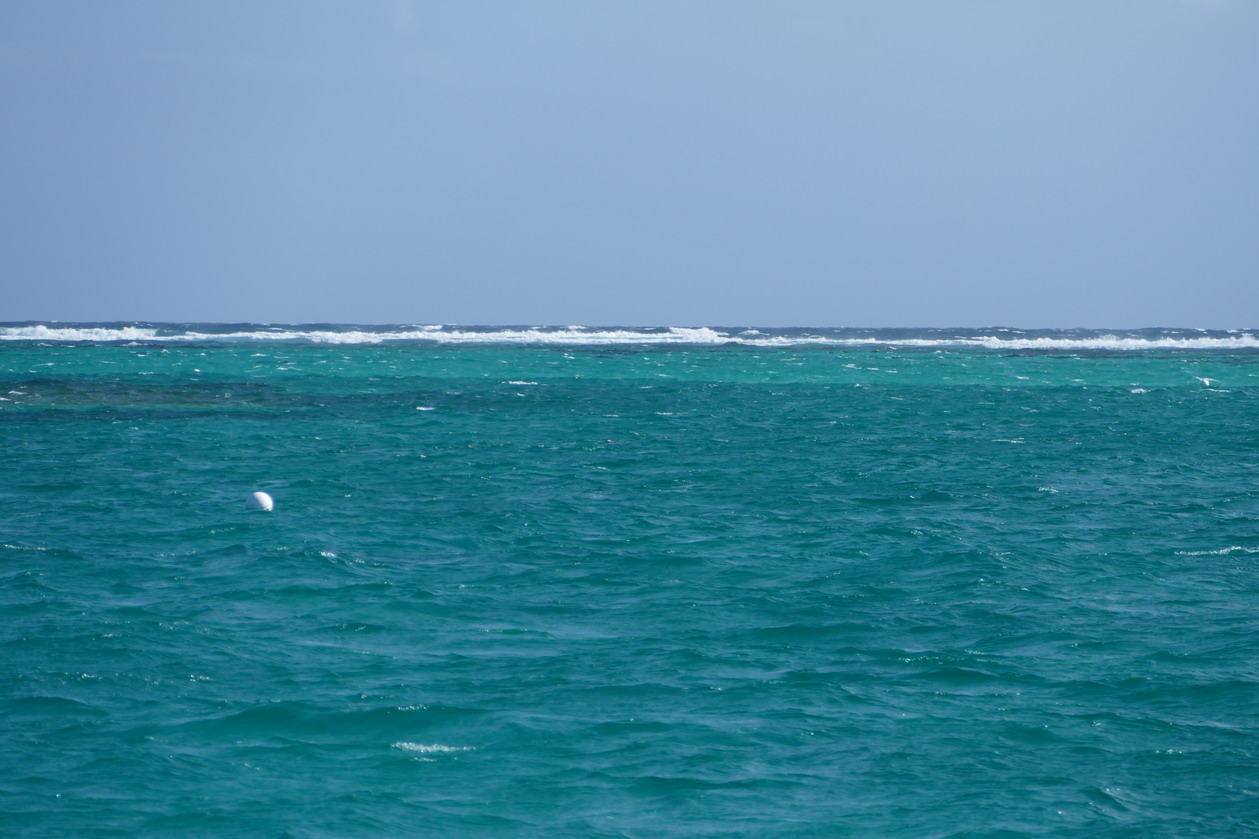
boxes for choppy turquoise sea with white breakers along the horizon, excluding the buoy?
[0,322,1259,839]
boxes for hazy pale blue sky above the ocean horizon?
[0,0,1259,329]
